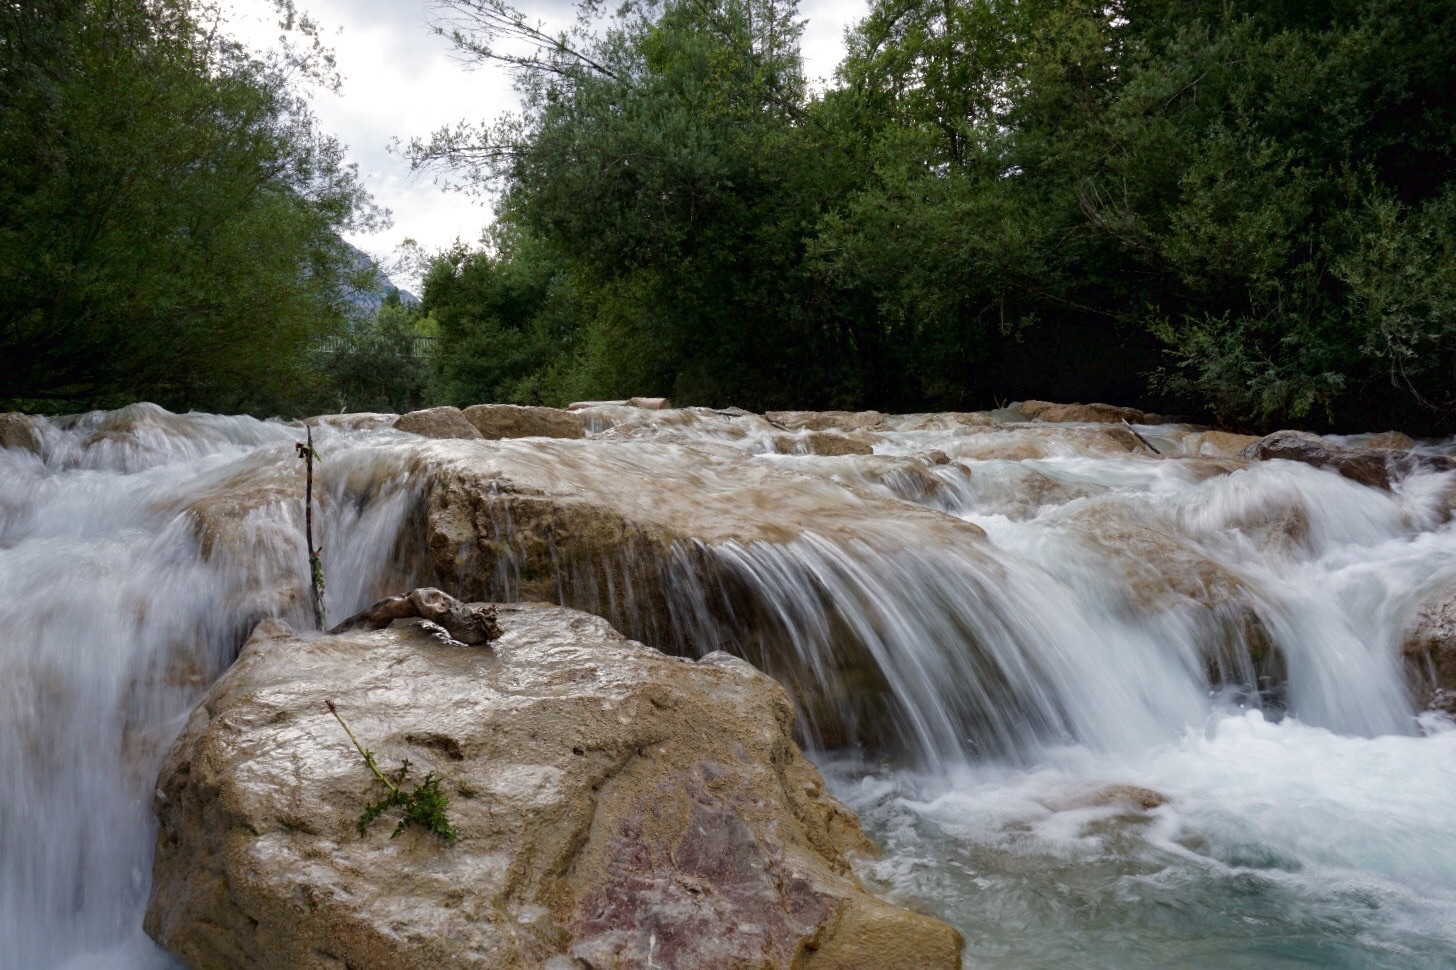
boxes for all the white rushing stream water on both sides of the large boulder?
[0,405,1456,970]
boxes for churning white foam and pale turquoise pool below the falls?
[827,712,1456,970]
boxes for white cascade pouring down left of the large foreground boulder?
[0,405,418,967]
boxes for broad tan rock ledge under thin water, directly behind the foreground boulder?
[421,440,986,649]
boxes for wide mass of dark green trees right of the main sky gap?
[414,0,1456,424]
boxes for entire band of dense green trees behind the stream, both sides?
[8,0,1456,428]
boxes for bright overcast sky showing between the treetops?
[233,0,868,288]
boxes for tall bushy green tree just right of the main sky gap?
[414,0,860,406]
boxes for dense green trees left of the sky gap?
[0,0,376,409]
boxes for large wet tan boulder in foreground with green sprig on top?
[146,604,961,970]
